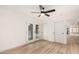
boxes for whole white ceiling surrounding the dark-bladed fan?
[0,5,79,25]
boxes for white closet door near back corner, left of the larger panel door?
[43,23,54,42]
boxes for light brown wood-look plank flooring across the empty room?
[2,37,79,54]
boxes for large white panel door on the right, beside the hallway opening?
[54,21,66,43]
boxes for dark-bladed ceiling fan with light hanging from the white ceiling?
[32,5,55,17]
